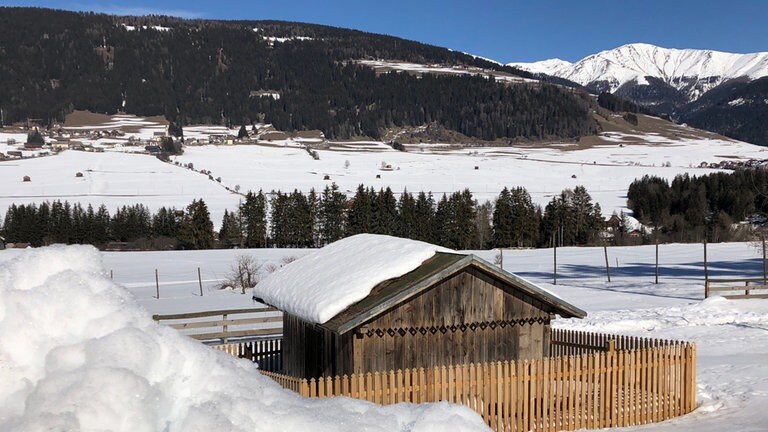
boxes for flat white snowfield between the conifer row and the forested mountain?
[0,126,768,230]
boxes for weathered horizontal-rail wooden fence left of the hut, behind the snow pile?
[152,307,283,344]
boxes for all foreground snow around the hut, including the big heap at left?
[0,243,768,432]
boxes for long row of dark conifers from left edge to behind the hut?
[2,184,604,249]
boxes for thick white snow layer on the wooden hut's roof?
[253,234,454,324]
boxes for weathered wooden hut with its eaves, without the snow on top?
[255,235,586,378]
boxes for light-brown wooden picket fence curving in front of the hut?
[262,332,696,431]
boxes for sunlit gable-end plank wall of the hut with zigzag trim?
[352,268,551,373]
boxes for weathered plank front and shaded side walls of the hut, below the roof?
[283,267,552,378]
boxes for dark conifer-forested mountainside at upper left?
[0,8,596,140]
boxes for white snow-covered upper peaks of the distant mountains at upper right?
[509,43,768,102]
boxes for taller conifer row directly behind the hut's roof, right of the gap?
[219,184,604,249]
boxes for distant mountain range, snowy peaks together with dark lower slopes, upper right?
[508,43,768,146]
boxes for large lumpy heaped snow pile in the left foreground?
[0,246,487,432]
